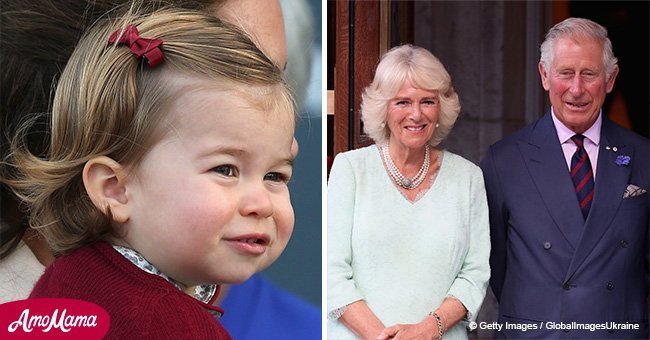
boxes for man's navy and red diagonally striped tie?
[571,134,594,220]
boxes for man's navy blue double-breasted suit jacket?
[481,112,650,339]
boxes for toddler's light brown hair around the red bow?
[2,6,295,253]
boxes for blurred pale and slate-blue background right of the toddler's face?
[262,0,323,307]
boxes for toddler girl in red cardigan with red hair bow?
[3,3,295,339]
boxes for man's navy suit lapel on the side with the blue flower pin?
[567,118,634,279]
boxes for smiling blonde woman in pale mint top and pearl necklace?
[327,45,490,339]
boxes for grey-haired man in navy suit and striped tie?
[481,18,650,339]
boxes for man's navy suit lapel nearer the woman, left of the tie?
[519,113,584,249]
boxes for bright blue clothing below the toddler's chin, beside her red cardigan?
[219,275,322,340]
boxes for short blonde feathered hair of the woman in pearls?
[361,44,460,146]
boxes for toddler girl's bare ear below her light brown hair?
[82,156,129,223]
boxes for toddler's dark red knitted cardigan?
[30,242,231,339]
